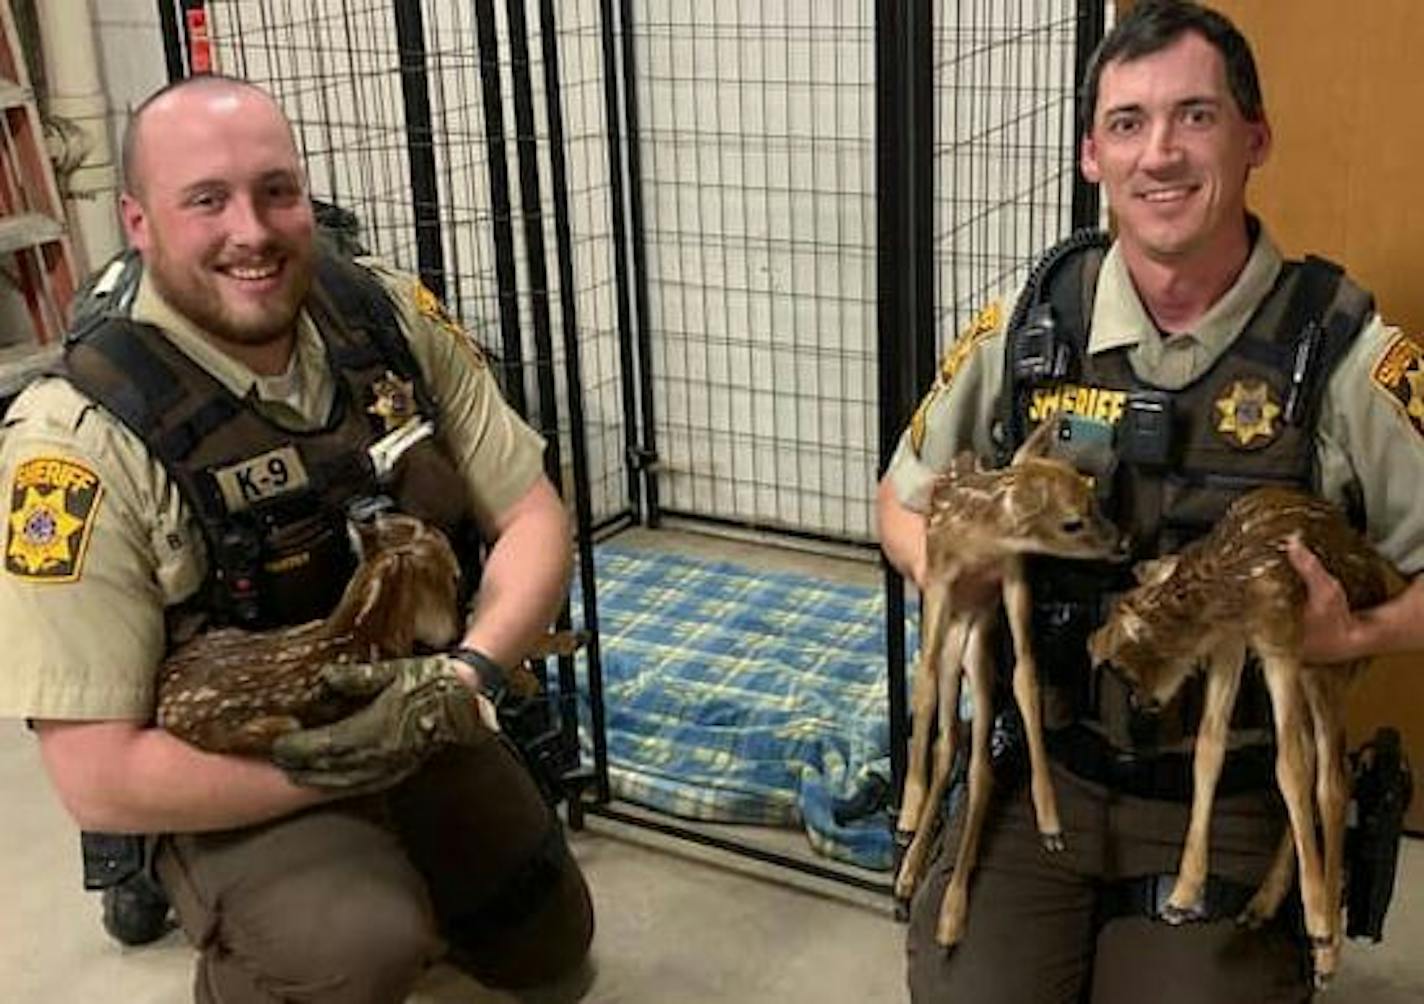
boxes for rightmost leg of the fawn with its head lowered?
[1302,666,1350,987]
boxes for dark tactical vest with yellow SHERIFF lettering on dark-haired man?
[995,231,1374,753]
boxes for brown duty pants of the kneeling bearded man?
[155,738,594,1004]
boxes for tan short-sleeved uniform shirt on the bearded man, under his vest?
[0,262,544,721]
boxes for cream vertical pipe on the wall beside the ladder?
[36,0,124,272]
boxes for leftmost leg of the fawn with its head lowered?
[1162,645,1246,924]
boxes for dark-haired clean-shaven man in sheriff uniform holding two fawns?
[879,0,1424,1004]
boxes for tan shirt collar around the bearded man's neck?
[132,272,335,424]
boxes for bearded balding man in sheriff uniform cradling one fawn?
[0,77,592,1004]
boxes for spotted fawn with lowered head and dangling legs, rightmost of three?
[1089,488,1405,987]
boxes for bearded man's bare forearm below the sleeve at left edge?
[34,721,330,833]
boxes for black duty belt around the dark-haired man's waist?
[1044,725,1276,802]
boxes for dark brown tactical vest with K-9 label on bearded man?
[58,253,478,628]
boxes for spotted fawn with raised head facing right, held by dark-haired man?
[896,420,1124,947]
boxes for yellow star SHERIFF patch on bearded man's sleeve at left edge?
[4,457,104,582]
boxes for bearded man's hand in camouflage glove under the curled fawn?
[272,655,493,792]
